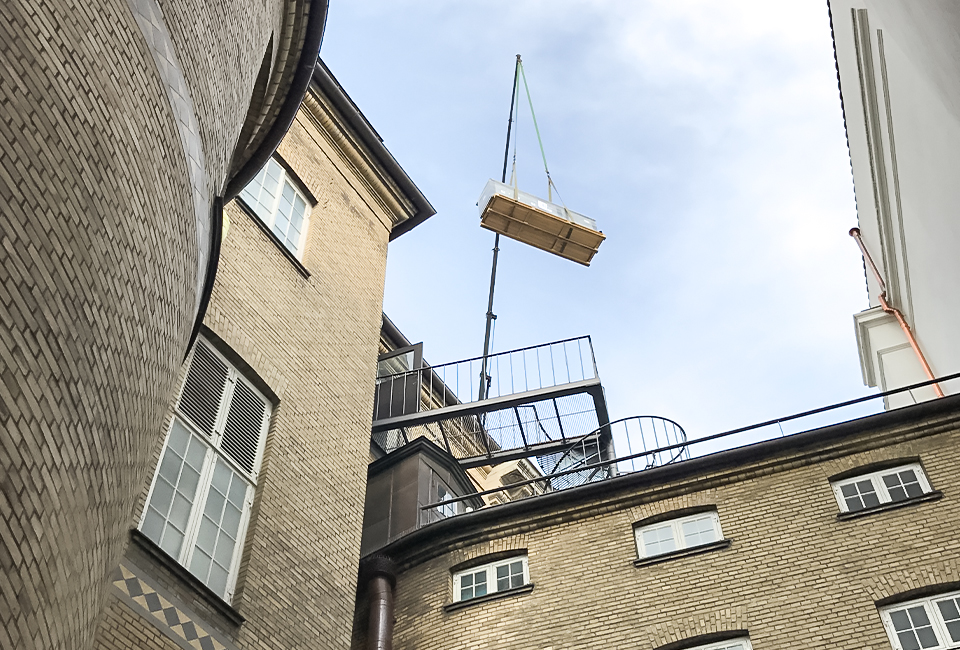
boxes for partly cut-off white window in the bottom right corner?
[880,592,960,650]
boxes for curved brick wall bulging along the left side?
[0,0,322,649]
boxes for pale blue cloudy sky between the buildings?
[321,0,881,450]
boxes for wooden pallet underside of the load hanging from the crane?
[480,194,606,266]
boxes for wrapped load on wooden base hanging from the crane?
[478,179,606,266]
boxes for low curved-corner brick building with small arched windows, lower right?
[353,384,960,650]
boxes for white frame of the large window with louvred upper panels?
[137,337,273,603]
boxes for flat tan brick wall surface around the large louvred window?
[91,83,416,650]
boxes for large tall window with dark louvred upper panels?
[140,340,270,601]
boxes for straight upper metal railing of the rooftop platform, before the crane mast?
[373,336,598,422]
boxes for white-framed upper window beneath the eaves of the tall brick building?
[240,158,310,259]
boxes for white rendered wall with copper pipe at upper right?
[830,0,960,408]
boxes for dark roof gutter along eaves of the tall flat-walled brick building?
[313,59,437,241]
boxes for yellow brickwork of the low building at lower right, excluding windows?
[382,410,960,650]
